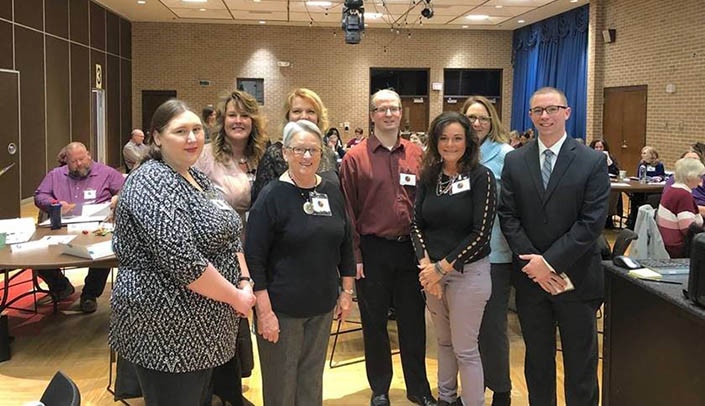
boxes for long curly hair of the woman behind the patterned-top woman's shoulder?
[211,90,268,167]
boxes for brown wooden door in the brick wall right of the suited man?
[602,86,648,176]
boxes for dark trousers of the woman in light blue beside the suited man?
[480,262,513,392]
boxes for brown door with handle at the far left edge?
[0,69,20,219]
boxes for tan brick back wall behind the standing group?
[132,23,513,143]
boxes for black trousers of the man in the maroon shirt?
[356,236,431,396]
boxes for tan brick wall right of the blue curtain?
[588,0,705,168]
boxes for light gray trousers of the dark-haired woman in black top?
[426,258,492,406]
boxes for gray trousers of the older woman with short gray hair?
[257,311,333,406]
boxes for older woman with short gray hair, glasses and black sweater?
[245,120,355,406]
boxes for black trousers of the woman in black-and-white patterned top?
[135,365,213,406]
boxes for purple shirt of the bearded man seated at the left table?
[34,162,125,215]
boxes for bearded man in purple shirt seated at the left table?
[34,142,125,313]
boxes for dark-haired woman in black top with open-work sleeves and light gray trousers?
[411,112,497,406]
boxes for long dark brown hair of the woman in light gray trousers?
[420,111,480,185]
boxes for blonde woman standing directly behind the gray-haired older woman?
[252,87,338,203]
